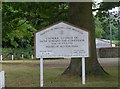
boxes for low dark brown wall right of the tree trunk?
[97,47,120,58]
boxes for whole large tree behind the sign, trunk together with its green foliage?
[2,2,118,76]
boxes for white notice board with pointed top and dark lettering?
[35,22,89,58]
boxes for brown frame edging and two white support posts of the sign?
[34,21,90,87]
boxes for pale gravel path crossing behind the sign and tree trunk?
[3,58,120,67]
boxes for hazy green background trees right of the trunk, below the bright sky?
[94,15,118,40]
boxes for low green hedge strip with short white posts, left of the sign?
[1,48,34,60]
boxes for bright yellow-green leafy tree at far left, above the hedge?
[2,3,36,47]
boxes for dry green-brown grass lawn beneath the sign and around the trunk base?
[3,60,118,87]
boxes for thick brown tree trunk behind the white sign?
[63,2,106,76]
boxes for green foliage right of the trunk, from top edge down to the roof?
[95,2,120,40]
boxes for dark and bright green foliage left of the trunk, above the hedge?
[2,2,68,48]
